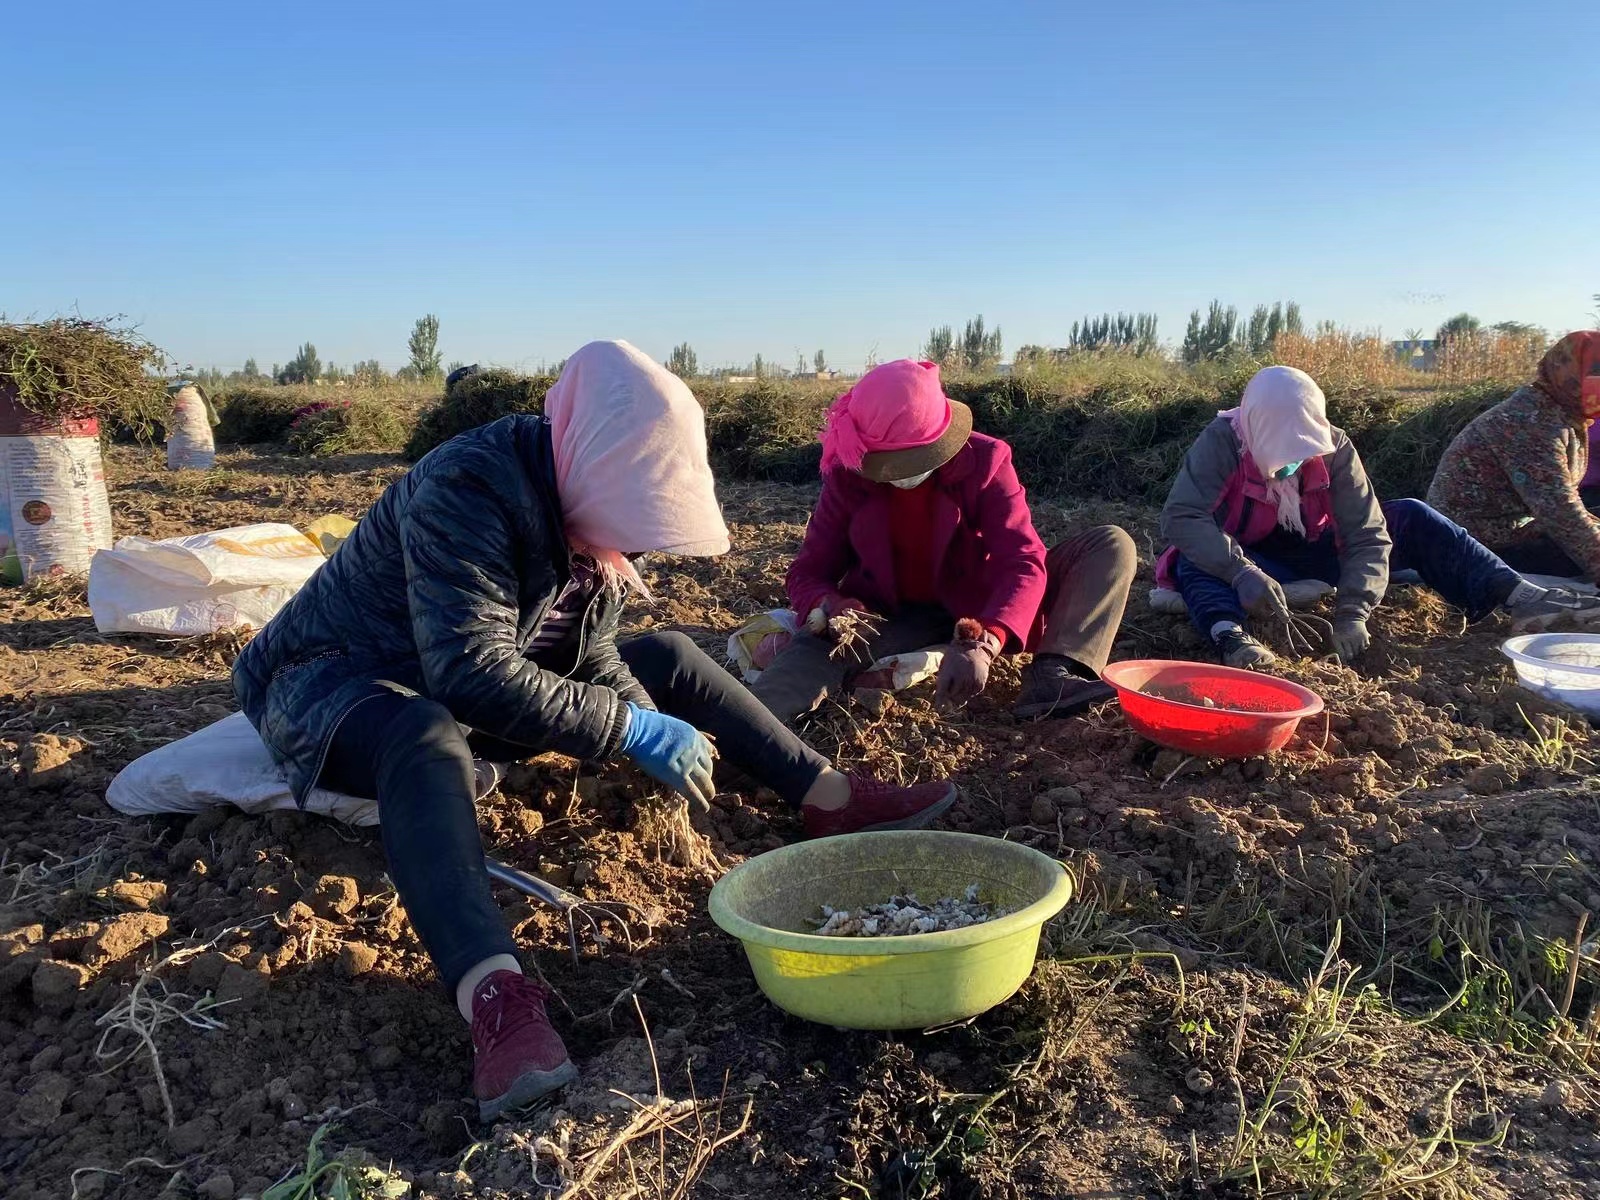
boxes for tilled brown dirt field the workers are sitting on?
[0,450,1600,1200]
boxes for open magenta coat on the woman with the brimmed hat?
[789,434,1045,650]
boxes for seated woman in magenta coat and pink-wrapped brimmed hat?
[752,358,1138,720]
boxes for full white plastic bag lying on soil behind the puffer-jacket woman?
[90,525,326,637]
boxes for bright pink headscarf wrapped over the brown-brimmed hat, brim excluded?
[822,358,950,470]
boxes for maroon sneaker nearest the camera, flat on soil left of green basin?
[472,971,578,1122]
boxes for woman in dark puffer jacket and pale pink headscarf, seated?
[234,342,955,1118]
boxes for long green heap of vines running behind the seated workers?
[387,354,1510,504]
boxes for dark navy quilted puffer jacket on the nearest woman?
[234,416,650,803]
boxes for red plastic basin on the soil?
[1104,658,1323,758]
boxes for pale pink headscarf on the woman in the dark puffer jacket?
[544,341,728,595]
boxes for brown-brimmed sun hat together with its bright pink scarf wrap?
[822,358,973,483]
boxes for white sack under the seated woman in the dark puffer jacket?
[106,712,378,826]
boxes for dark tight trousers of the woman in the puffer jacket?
[318,634,827,989]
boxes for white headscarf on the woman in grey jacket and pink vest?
[1221,366,1334,536]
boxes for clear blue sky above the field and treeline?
[0,0,1600,370]
